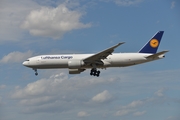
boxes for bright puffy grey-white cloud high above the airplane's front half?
[21,4,91,39]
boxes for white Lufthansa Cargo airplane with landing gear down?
[22,31,168,77]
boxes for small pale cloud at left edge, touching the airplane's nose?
[0,50,33,63]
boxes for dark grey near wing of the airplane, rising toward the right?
[83,42,124,64]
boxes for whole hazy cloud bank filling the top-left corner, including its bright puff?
[0,0,91,42]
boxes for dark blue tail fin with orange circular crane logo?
[139,31,164,54]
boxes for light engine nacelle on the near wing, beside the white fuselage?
[68,60,84,69]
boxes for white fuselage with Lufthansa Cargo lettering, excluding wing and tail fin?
[23,53,163,69]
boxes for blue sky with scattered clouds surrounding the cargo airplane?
[0,0,180,120]
